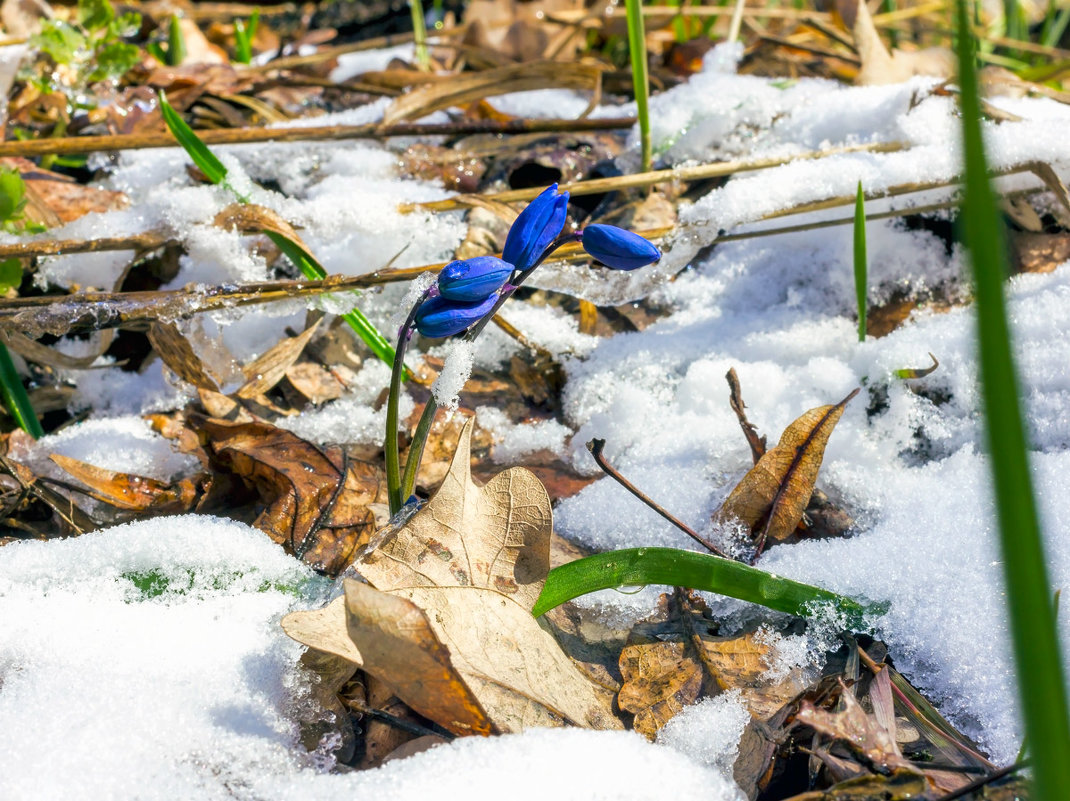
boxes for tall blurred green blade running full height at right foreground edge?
[957,0,1070,801]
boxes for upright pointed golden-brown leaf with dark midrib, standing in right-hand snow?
[714,389,858,549]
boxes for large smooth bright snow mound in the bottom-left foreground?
[0,515,743,801]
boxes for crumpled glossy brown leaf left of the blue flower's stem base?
[196,415,385,575]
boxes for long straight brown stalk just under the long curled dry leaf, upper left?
[0,117,636,158]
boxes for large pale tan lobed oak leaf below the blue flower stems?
[282,420,622,734]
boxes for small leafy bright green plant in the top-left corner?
[30,0,141,91]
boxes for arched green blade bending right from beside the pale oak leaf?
[532,548,886,629]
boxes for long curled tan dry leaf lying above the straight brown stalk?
[383,61,602,125]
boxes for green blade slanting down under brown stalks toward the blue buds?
[159,93,394,365]
